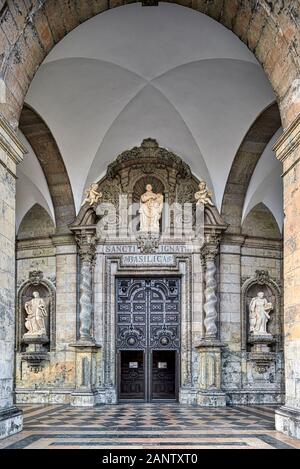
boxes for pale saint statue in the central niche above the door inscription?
[140,184,164,233]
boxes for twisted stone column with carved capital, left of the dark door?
[76,231,96,342]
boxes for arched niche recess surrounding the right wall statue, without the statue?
[241,270,282,351]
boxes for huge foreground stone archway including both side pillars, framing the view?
[0,0,300,436]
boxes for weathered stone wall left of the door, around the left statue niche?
[15,236,77,403]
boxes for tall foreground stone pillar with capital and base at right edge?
[274,115,300,438]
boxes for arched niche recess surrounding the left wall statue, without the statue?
[16,270,56,352]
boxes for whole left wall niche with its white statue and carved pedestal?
[16,271,55,372]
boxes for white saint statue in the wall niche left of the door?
[24,291,47,337]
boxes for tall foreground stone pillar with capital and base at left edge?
[0,115,26,438]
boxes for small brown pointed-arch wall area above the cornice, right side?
[242,202,281,239]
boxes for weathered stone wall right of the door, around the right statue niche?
[219,236,284,404]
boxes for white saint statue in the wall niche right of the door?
[249,292,273,335]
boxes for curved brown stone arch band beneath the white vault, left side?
[20,105,75,232]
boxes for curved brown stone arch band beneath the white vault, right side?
[221,103,281,233]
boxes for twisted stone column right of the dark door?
[202,245,218,339]
